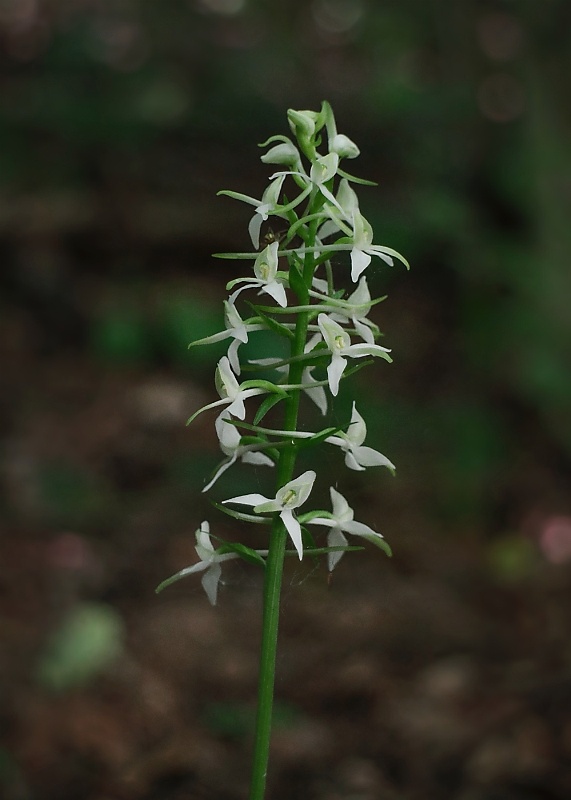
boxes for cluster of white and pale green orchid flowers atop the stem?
[159,103,408,604]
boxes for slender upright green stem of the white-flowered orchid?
[250,219,315,800]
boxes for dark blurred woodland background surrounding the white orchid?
[0,0,571,800]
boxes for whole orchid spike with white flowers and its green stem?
[154,103,408,800]
